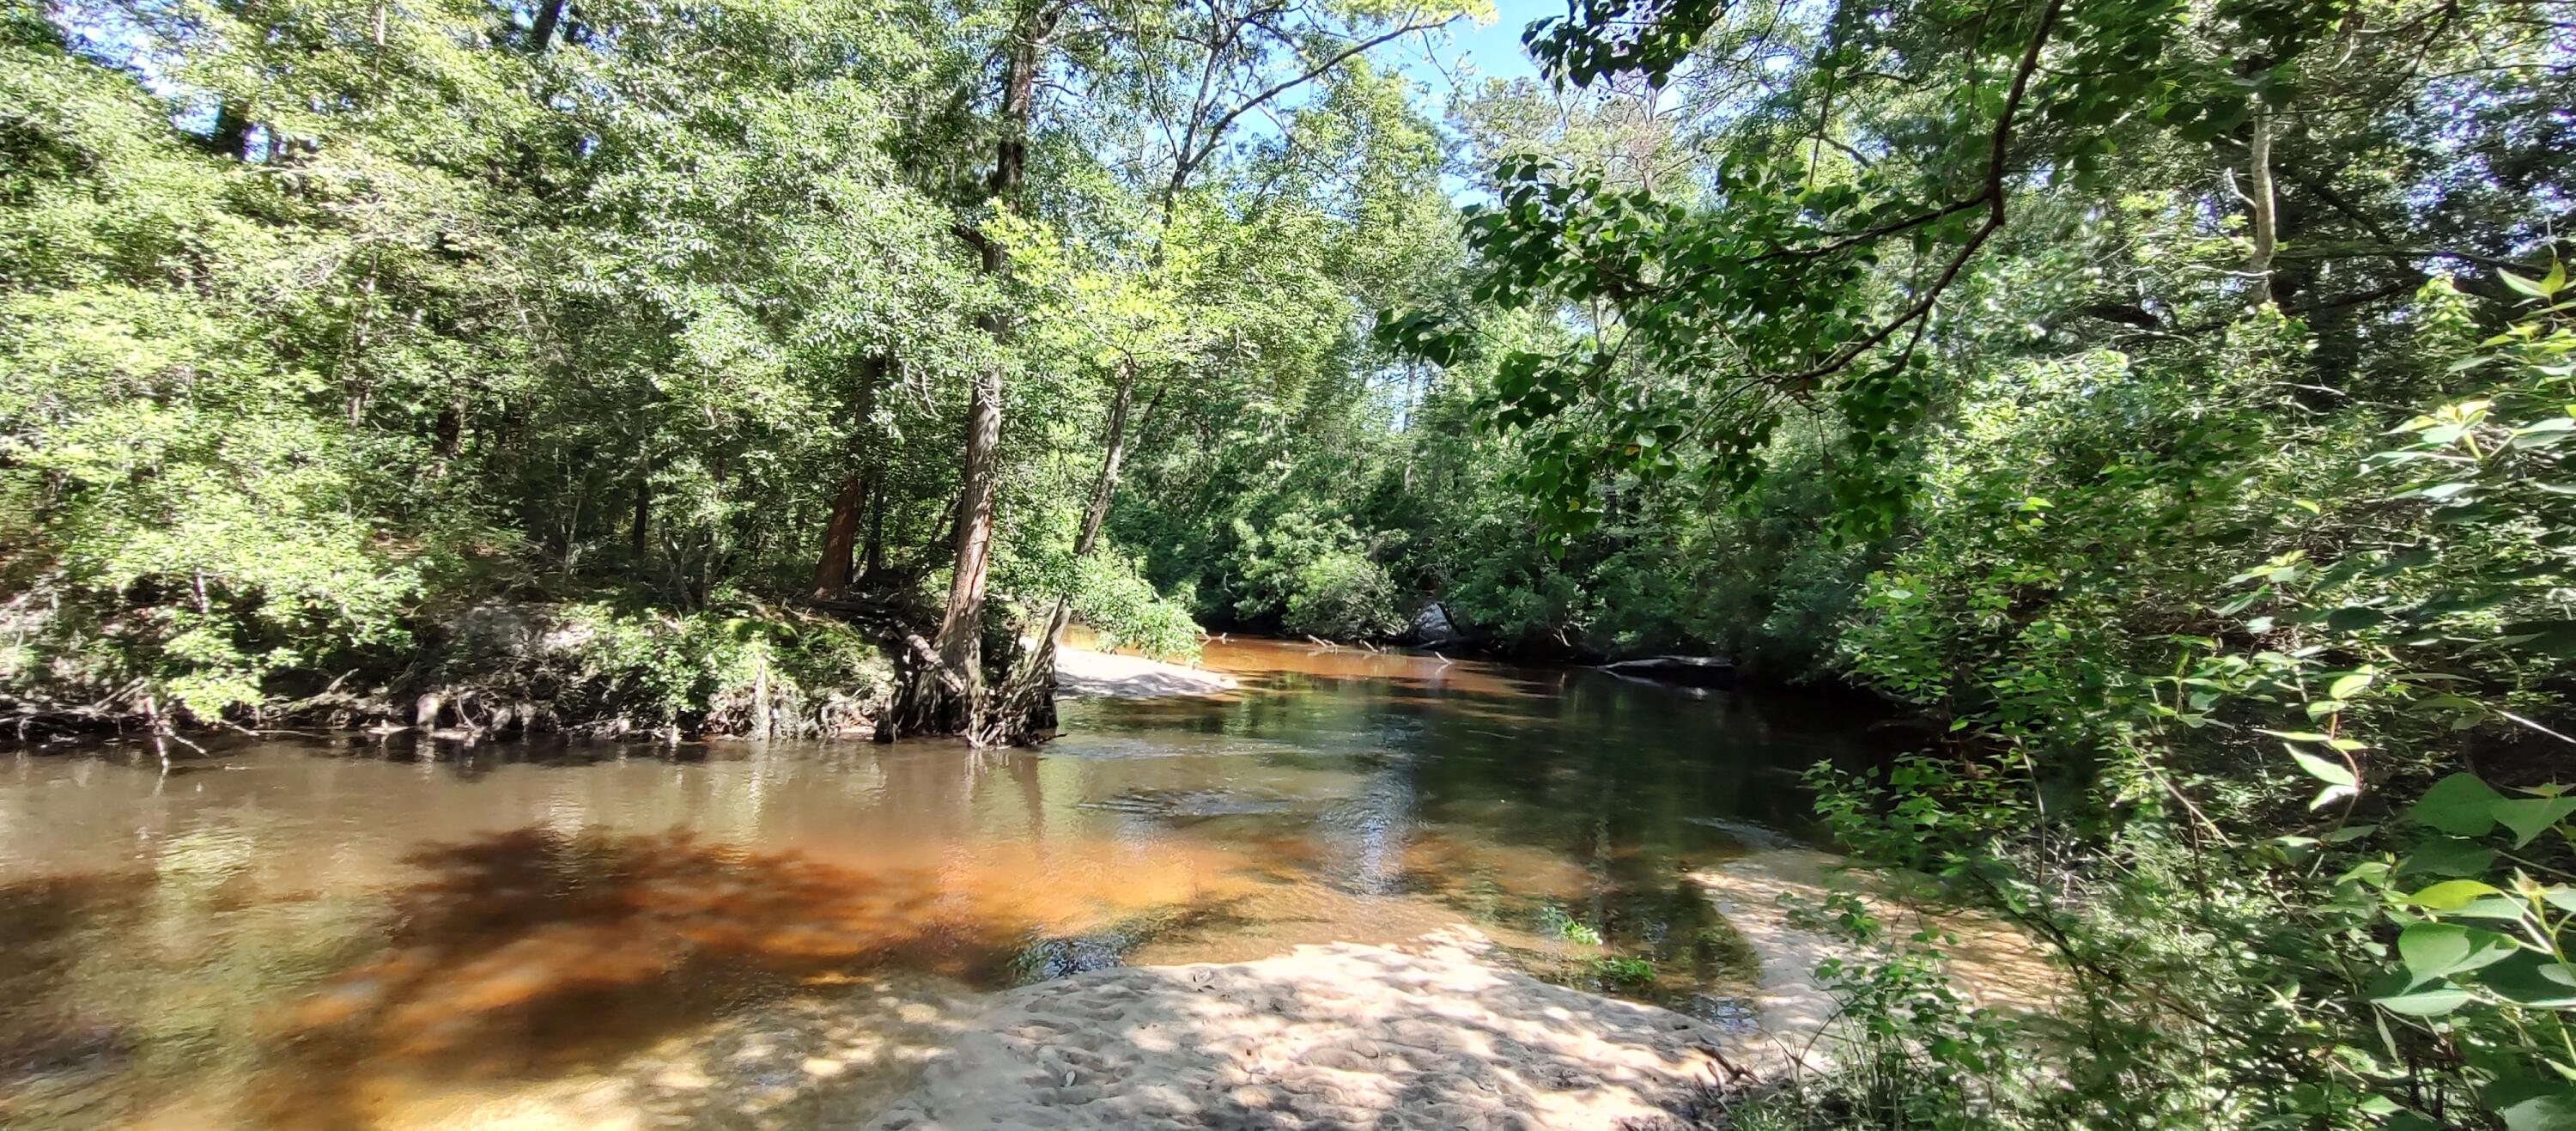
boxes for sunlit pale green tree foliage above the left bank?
[0,0,1453,727]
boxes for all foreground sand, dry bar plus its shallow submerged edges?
[191,850,2058,1131]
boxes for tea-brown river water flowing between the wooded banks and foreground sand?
[0,642,1886,1128]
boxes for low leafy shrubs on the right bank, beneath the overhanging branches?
[1816,278,2576,1128]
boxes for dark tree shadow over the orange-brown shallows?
[263,830,1247,1126]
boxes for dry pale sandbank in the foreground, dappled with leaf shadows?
[873,927,1759,1131]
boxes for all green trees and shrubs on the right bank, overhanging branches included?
[1378,3,2576,1128]
